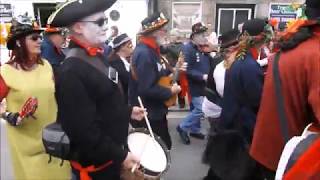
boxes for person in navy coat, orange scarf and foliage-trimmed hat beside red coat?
[221,19,272,143]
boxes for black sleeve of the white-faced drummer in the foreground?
[57,73,127,163]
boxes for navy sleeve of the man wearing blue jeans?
[182,46,204,82]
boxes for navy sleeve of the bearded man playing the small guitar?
[136,53,172,100]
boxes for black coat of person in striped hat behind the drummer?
[108,54,130,103]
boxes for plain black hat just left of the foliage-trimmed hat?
[219,29,240,48]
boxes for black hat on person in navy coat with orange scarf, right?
[242,19,268,36]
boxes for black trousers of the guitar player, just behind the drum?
[131,115,172,150]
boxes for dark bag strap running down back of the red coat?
[273,52,290,142]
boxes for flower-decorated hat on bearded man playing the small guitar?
[140,12,169,34]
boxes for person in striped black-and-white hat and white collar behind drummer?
[108,34,133,103]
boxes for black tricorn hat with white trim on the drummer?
[48,0,116,27]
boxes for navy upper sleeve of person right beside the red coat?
[241,64,263,108]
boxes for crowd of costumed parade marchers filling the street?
[0,0,320,180]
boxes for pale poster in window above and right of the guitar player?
[172,2,202,32]
